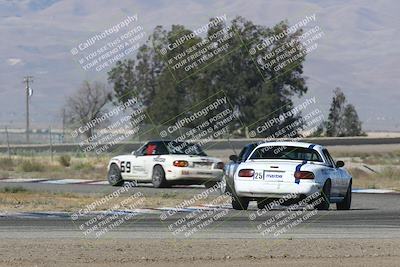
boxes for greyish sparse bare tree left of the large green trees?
[66,81,112,138]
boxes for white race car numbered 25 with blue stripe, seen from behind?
[223,142,352,210]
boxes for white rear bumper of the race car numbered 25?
[235,180,322,198]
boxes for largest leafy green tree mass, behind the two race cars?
[108,17,307,135]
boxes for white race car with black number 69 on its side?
[107,141,224,187]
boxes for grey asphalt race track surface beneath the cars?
[0,183,400,239]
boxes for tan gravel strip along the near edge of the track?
[0,239,400,266]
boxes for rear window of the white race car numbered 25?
[250,146,322,162]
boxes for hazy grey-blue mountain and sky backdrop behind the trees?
[0,0,400,131]
